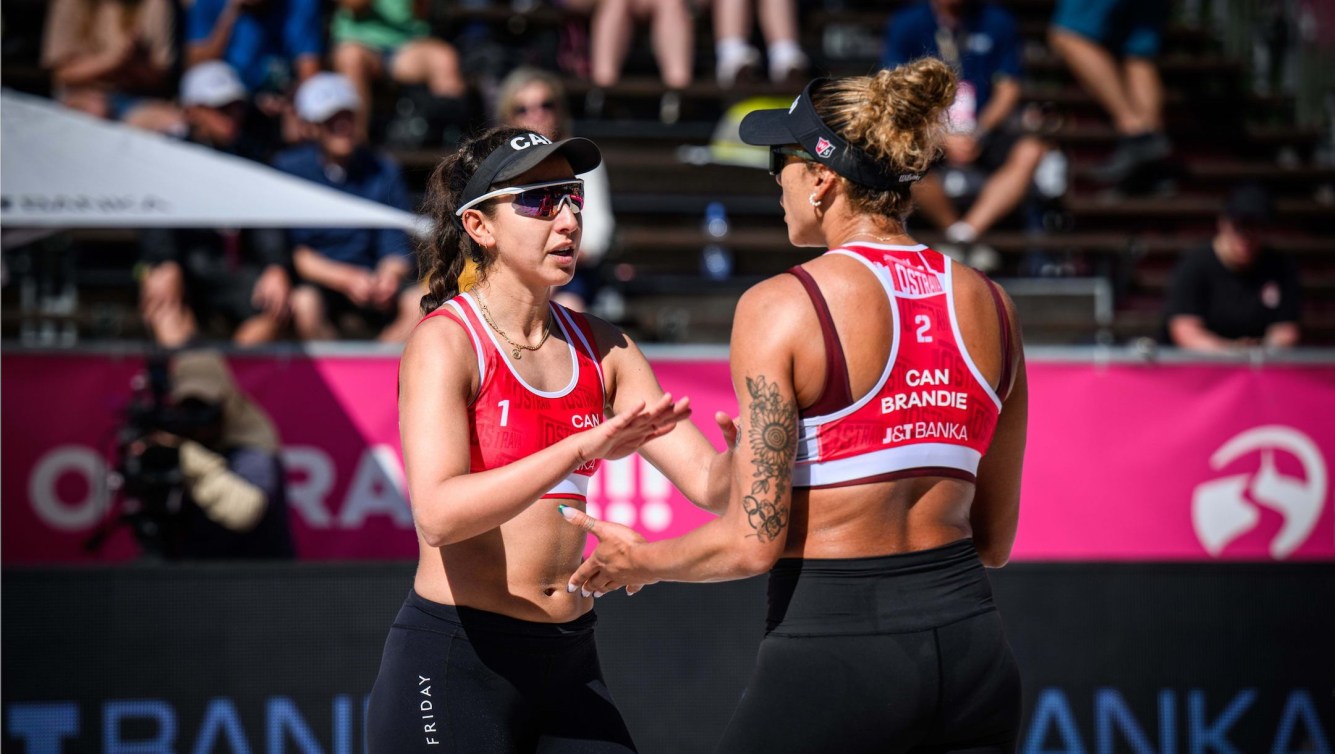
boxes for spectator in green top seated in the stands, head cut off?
[330,0,467,140]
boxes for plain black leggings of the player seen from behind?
[718,540,1020,754]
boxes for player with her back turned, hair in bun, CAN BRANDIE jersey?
[567,59,1027,754]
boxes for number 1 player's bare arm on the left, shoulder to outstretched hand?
[399,318,690,547]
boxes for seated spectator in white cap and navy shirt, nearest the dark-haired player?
[274,73,425,340]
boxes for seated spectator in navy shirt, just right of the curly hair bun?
[881,0,1052,271]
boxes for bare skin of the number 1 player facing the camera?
[399,156,730,622]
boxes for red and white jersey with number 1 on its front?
[423,294,606,499]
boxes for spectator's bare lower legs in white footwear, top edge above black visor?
[714,0,810,88]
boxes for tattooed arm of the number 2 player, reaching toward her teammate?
[569,280,798,593]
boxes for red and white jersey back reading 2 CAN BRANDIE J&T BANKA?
[793,243,1009,487]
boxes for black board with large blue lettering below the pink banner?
[3,563,1335,754]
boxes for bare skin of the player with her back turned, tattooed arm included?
[558,145,1028,590]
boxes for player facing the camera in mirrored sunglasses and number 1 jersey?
[367,127,734,753]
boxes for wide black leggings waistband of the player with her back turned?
[766,539,996,637]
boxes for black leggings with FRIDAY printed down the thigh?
[366,593,635,754]
